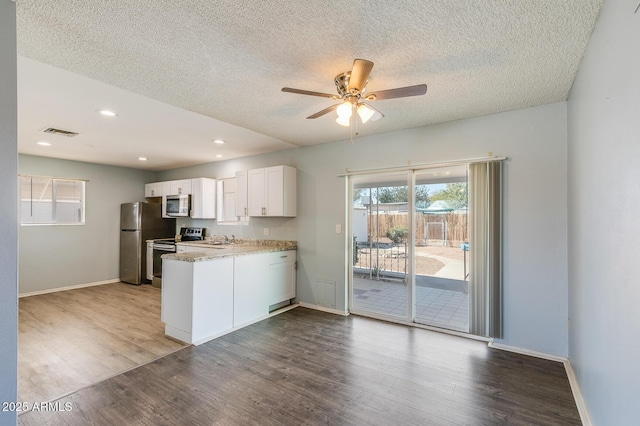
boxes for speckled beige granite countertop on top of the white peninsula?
[162,240,297,262]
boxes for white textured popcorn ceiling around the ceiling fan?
[17,0,602,170]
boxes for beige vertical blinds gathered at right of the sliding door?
[469,161,503,338]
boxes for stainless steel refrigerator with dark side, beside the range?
[120,202,176,284]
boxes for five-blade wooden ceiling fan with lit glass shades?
[282,59,427,127]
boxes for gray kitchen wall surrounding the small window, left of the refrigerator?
[19,155,156,293]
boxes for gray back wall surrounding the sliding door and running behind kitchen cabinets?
[159,102,568,356]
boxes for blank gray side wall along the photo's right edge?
[568,1,640,425]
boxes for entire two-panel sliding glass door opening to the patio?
[350,166,469,332]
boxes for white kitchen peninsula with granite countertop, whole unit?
[162,240,297,345]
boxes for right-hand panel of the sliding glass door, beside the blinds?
[413,166,469,332]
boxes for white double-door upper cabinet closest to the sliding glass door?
[247,166,297,217]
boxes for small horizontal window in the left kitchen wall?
[20,176,85,225]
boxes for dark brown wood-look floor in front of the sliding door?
[19,308,580,425]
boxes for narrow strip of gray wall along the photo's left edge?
[0,0,18,425]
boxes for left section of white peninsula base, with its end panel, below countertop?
[162,257,233,344]
